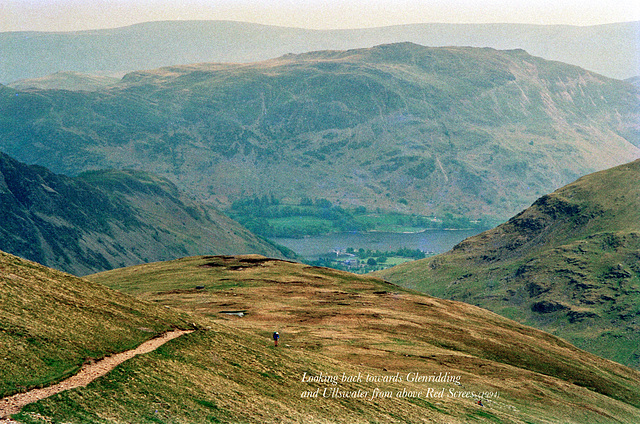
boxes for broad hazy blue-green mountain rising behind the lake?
[0,43,640,219]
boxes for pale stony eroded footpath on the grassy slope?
[0,330,193,423]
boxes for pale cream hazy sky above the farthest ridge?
[0,0,640,31]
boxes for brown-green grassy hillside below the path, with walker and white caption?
[26,256,640,424]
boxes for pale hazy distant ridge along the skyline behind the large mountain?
[0,21,640,84]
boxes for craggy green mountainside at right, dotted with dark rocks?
[379,161,640,368]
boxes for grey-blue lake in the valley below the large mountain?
[271,230,482,260]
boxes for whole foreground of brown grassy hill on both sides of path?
[5,248,640,424]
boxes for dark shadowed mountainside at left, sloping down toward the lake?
[0,153,282,275]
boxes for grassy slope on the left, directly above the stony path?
[0,252,188,396]
